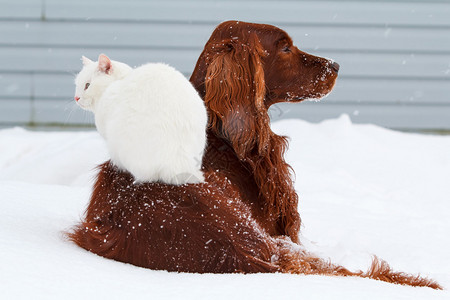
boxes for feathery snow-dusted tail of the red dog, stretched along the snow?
[276,238,442,290]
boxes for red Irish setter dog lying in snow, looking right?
[69,21,440,288]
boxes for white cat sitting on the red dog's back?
[75,54,207,184]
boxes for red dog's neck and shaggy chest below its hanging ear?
[203,129,300,240]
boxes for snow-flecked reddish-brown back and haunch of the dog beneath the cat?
[69,162,278,273]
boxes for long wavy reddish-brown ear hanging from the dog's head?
[204,34,270,158]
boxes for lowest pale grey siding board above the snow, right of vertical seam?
[21,100,450,129]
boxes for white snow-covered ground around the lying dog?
[0,116,450,299]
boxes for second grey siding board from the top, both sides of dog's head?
[0,21,450,54]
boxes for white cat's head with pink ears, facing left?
[74,54,131,112]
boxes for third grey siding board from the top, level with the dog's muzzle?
[0,47,450,80]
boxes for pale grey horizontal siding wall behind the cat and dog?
[0,0,450,130]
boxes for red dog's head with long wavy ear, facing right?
[190,21,339,156]
